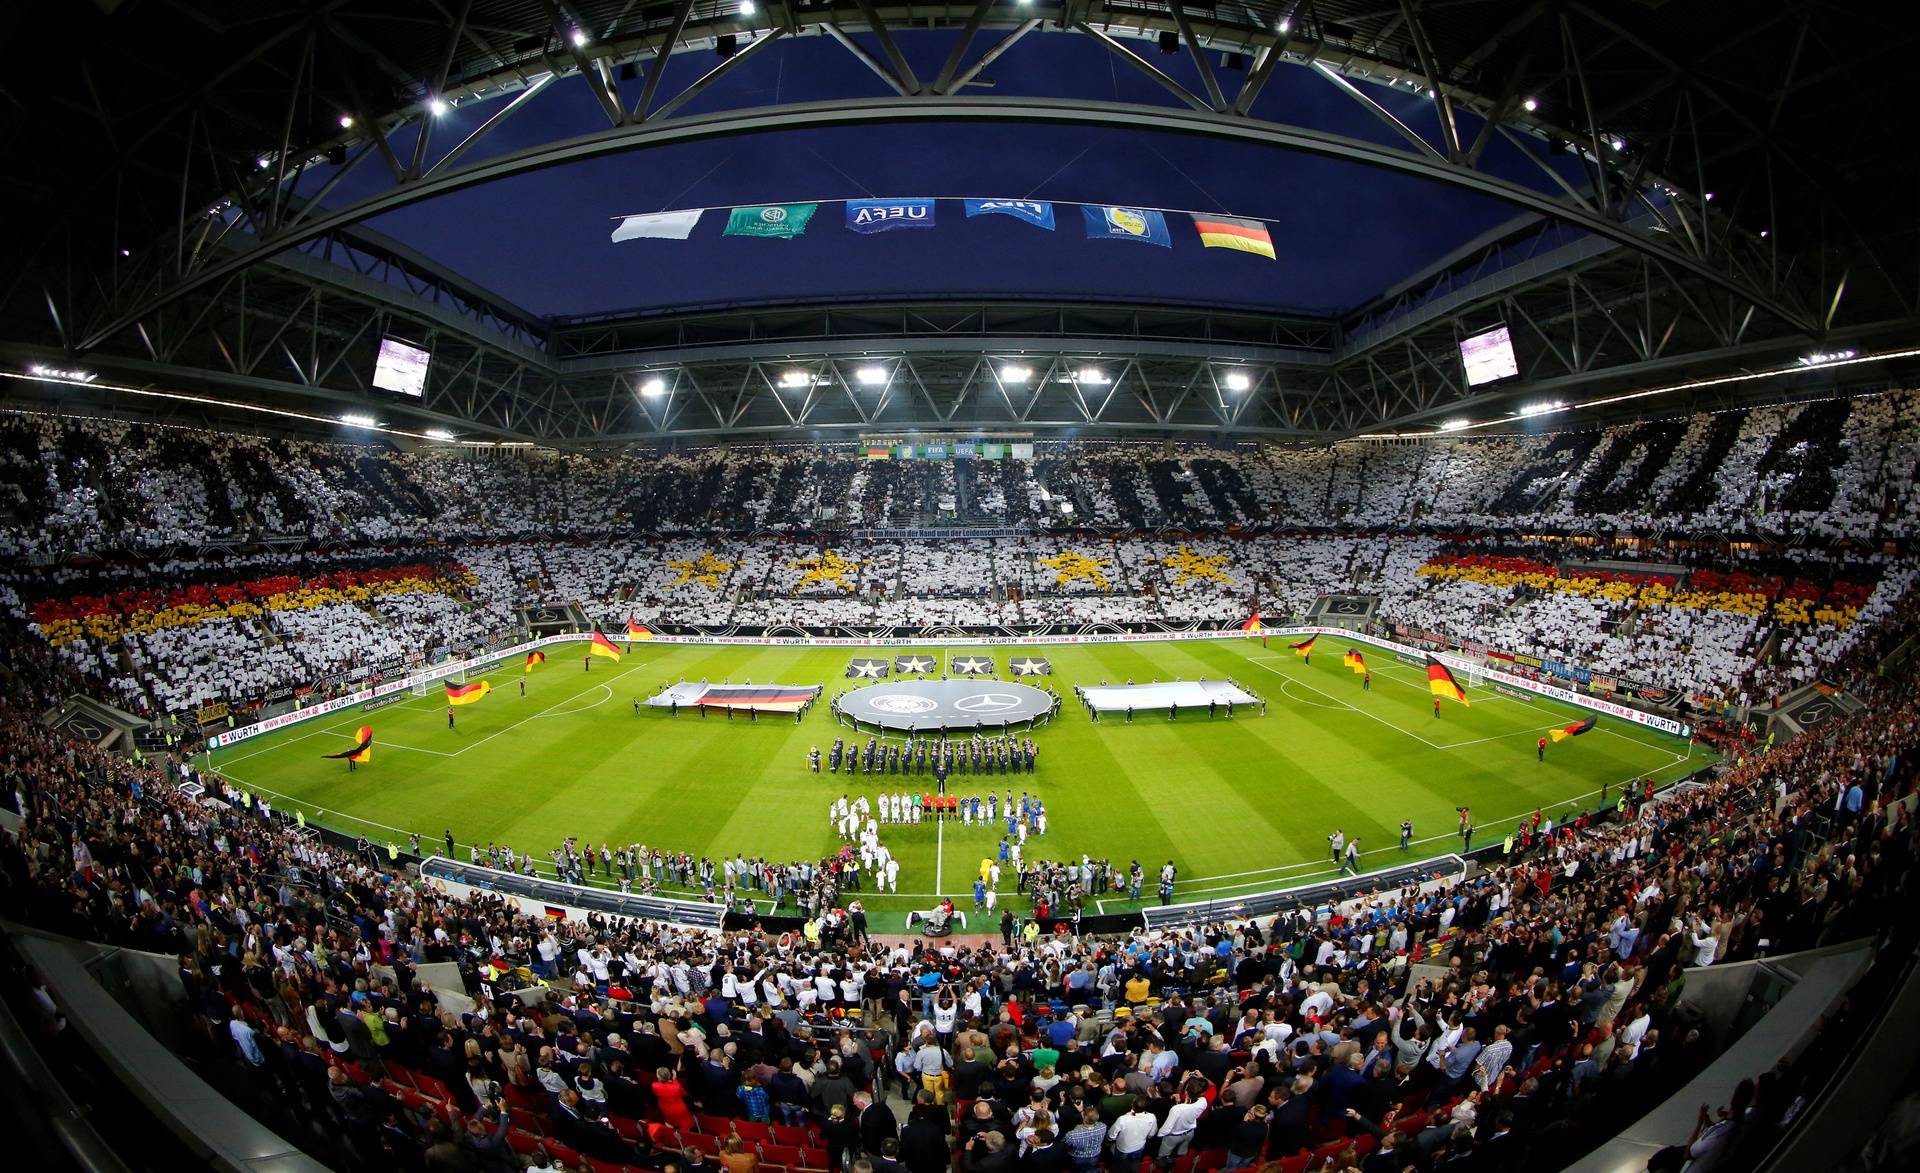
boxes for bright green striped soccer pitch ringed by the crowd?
[202,637,1709,927]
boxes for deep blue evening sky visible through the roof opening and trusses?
[301,33,1578,315]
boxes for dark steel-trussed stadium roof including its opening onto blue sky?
[0,0,1920,445]
